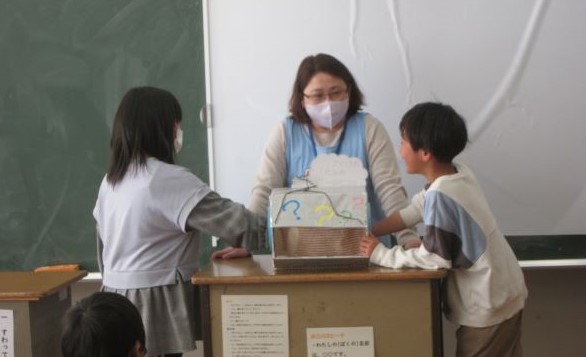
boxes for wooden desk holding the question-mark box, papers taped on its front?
[191,255,446,357]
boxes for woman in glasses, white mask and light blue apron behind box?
[212,54,420,258]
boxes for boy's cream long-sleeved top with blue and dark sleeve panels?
[370,164,527,327]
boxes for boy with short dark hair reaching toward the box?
[361,103,527,357]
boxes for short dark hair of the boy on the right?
[399,103,468,163]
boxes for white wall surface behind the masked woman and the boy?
[208,0,586,235]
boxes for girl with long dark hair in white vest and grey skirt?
[94,87,266,356]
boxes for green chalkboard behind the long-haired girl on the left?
[0,0,208,271]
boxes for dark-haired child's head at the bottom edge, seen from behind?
[61,292,146,357]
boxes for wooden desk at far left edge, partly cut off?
[0,271,87,357]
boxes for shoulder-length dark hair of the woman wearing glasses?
[289,53,364,123]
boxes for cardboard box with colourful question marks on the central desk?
[269,186,369,270]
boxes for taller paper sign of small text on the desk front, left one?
[222,295,289,357]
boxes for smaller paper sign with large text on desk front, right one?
[307,326,374,357]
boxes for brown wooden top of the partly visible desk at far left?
[0,271,87,301]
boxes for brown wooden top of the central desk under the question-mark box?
[191,254,447,285]
